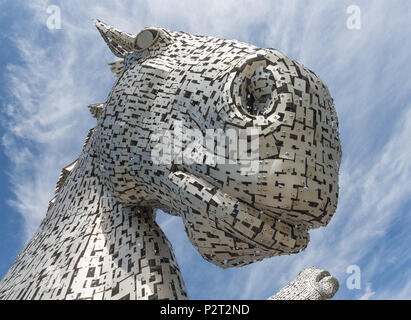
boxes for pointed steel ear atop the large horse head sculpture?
[93,19,136,58]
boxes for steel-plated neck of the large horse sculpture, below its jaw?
[0,140,187,299]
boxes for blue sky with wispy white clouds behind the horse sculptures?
[0,0,411,299]
